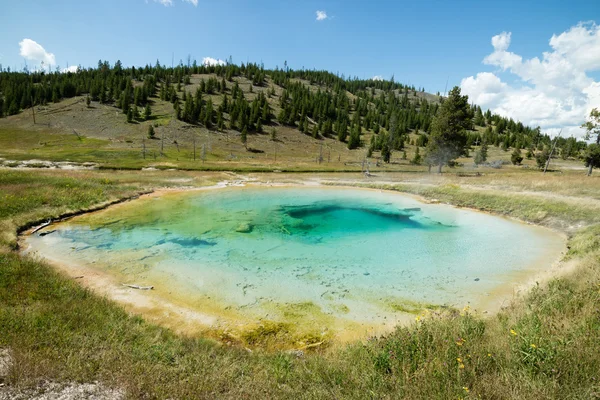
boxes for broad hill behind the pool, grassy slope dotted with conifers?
[0,62,585,170]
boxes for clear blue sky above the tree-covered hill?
[0,0,600,136]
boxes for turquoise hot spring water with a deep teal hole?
[28,187,563,334]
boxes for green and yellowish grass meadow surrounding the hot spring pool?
[0,170,600,399]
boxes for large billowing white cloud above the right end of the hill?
[461,23,600,136]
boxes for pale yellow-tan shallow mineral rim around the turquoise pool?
[23,185,565,347]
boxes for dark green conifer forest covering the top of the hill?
[0,60,587,171]
